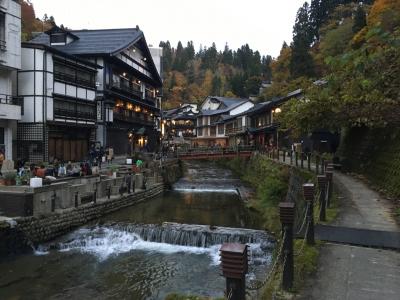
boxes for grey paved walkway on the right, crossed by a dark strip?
[272,155,400,300]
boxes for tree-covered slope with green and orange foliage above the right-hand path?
[268,0,400,134]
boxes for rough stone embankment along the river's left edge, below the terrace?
[0,161,182,256]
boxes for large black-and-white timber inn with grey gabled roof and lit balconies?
[17,27,162,161]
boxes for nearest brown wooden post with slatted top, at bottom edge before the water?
[219,243,248,300]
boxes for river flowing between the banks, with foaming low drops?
[0,163,273,299]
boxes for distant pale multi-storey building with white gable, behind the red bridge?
[194,96,254,146]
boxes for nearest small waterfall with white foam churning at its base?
[35,223,274,265]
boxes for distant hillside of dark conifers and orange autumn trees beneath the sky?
[160,41,272,107]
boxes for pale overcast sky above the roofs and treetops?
[31,0,305,57]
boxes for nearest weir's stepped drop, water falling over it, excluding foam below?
[40,222,274,251]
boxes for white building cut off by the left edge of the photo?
[0,0,21,160]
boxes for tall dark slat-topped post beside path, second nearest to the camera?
[279,202,295,291]
